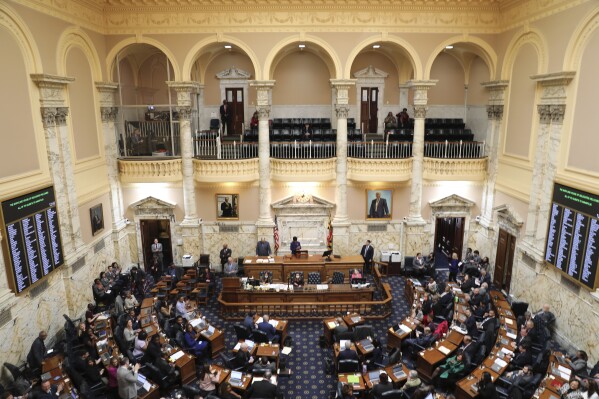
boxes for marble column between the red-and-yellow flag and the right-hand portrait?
[330,79,356,227]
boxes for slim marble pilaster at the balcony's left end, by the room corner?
[96,82,131,265]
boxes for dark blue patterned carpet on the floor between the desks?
[197,272,446,399]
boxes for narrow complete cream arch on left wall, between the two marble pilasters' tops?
[56,27,102,82]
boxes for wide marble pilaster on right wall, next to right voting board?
[523,72,575,263]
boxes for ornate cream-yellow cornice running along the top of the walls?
[20,0,586,35]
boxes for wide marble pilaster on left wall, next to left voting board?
[31,74,85,264]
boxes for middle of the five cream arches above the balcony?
[263,34,342,80]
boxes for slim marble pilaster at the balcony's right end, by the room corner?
[479,80,508,228]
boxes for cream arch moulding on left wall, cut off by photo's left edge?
[0,3,43,73]
